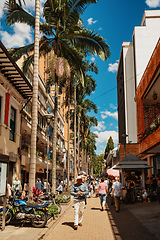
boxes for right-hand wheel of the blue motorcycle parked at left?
[31,208,47,228]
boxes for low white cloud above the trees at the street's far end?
[94,131,118,145]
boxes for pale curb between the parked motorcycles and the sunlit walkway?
[35,199,73,240]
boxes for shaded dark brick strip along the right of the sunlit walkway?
[106,197,157,240]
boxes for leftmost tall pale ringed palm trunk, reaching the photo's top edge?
[29,0,40,202]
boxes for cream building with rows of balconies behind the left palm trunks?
[17,56,65,182]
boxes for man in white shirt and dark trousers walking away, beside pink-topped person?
[111,177,122,212]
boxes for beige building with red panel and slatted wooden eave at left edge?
[0,41,32,184]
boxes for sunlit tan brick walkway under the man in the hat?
[41,198,115,240]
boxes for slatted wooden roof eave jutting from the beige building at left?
[0,41,32,99]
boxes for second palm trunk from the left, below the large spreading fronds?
[52,79,58,194]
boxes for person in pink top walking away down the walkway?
[97,178,108,211]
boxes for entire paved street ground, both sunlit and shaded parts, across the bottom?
[0,198,160,240]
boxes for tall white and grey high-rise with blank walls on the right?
[117,10,160,160]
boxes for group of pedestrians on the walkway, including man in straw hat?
[70,174,122,230]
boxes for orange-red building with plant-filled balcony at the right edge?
[136,39,160,177]
